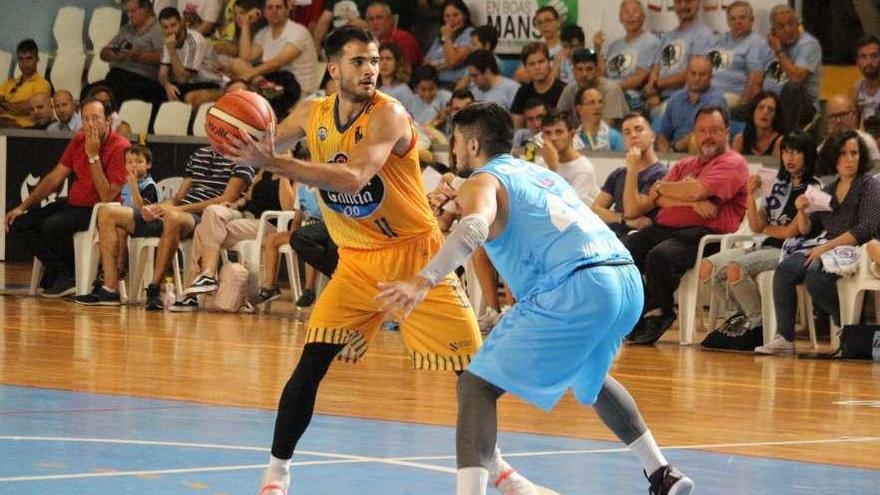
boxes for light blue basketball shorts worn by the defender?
[468,265,644,410]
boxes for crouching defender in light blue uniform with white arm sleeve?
[377,103,694,495]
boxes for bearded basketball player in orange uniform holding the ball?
[230,27,537,495]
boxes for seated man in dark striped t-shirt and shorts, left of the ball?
[75,146,255,310]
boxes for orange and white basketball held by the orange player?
[205,90,275,153]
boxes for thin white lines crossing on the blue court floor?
[0,435,880,483]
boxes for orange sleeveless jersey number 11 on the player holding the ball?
[306,91,439,249]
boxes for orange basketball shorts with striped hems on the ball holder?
[306,233,482,370]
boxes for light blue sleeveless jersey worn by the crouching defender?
[476,155,632,299]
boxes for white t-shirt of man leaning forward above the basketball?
[254,21,320,94]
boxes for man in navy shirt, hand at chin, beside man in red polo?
[592,113,667,238]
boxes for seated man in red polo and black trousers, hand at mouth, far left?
[6,99,131,297]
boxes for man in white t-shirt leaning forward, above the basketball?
[227,0,318,95]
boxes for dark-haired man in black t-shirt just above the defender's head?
[510,42,565,129]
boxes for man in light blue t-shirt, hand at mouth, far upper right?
[764,5,822,132]
